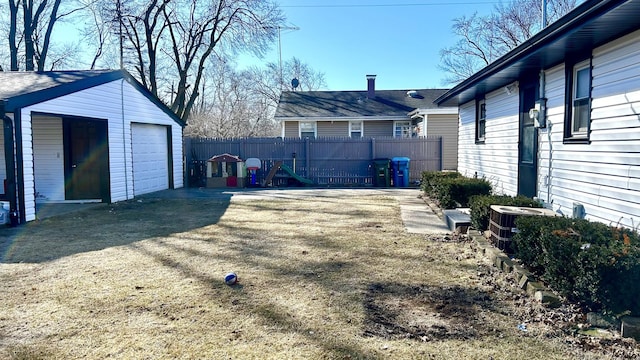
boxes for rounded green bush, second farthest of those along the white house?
[433,177,491,209]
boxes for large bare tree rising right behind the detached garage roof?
[117,0,284,121]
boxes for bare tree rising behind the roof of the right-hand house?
[439,0,576,85]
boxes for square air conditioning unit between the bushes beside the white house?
[489,205,557,254]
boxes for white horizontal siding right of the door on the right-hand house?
[539,32,640,227]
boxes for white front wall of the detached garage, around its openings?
[21,80,184,221]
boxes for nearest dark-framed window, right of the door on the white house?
[565,60,591,141]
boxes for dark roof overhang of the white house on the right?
[435,0,640,106]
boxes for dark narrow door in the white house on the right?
[518,81,538,198]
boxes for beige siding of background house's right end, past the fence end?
[421,114,458,170]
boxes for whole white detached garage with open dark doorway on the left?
[0,70,184,222]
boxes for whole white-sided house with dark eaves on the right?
[436,0,640,228]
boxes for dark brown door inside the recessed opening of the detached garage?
[63,118,109,202]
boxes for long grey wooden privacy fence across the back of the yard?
[184,136,442,187]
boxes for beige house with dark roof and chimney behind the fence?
[275,75,458,170]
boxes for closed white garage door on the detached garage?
[131,124,169,195]
